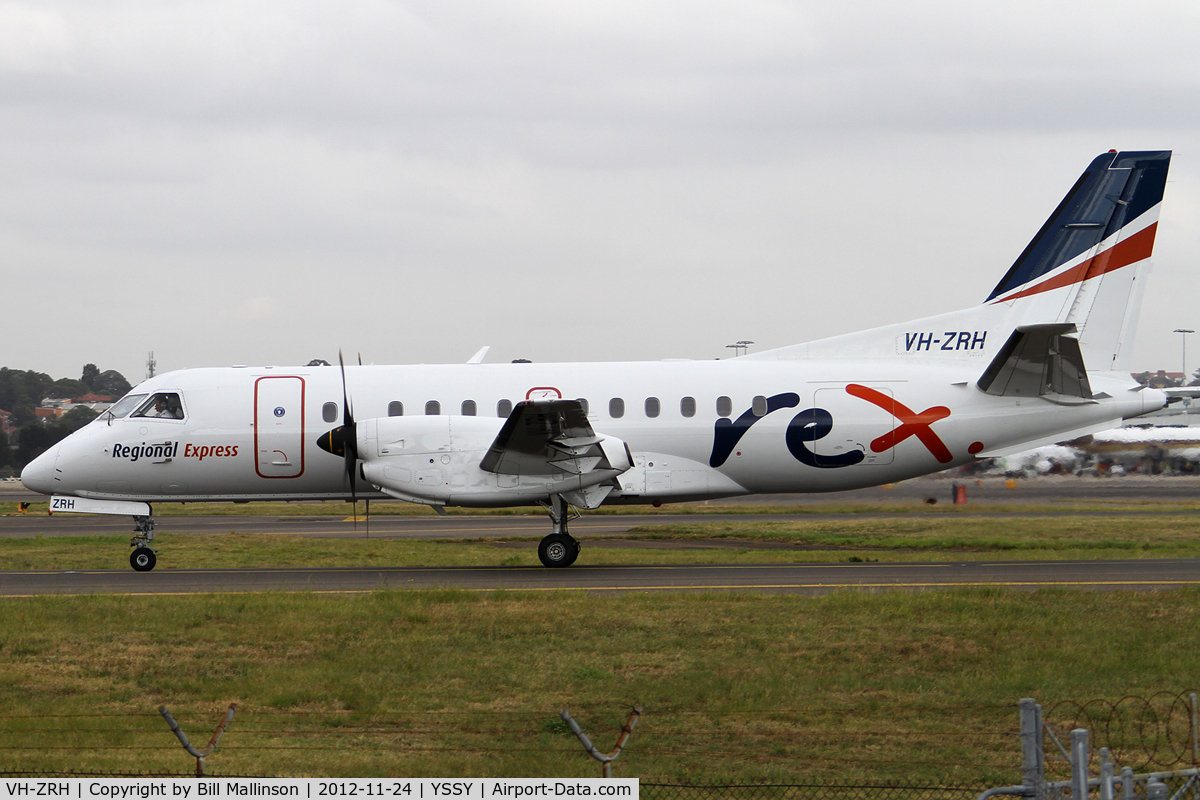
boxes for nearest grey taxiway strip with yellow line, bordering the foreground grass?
[7,559,1200,597]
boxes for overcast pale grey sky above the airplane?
[0,0,1200,383]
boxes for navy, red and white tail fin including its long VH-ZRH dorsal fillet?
[744,150,1171,369]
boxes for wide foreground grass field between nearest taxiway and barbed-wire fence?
[0,590,1200,787]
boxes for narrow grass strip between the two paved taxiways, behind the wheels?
[0,513,1200,570]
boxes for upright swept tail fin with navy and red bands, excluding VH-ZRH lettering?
[985,150,1171,369]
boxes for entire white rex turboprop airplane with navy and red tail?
[22,151,1171,571]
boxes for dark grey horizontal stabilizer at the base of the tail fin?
[977,323,1094,405]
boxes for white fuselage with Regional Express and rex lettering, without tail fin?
[22,357,1163,506]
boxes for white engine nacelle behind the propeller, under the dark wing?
[356,415,632,509]
